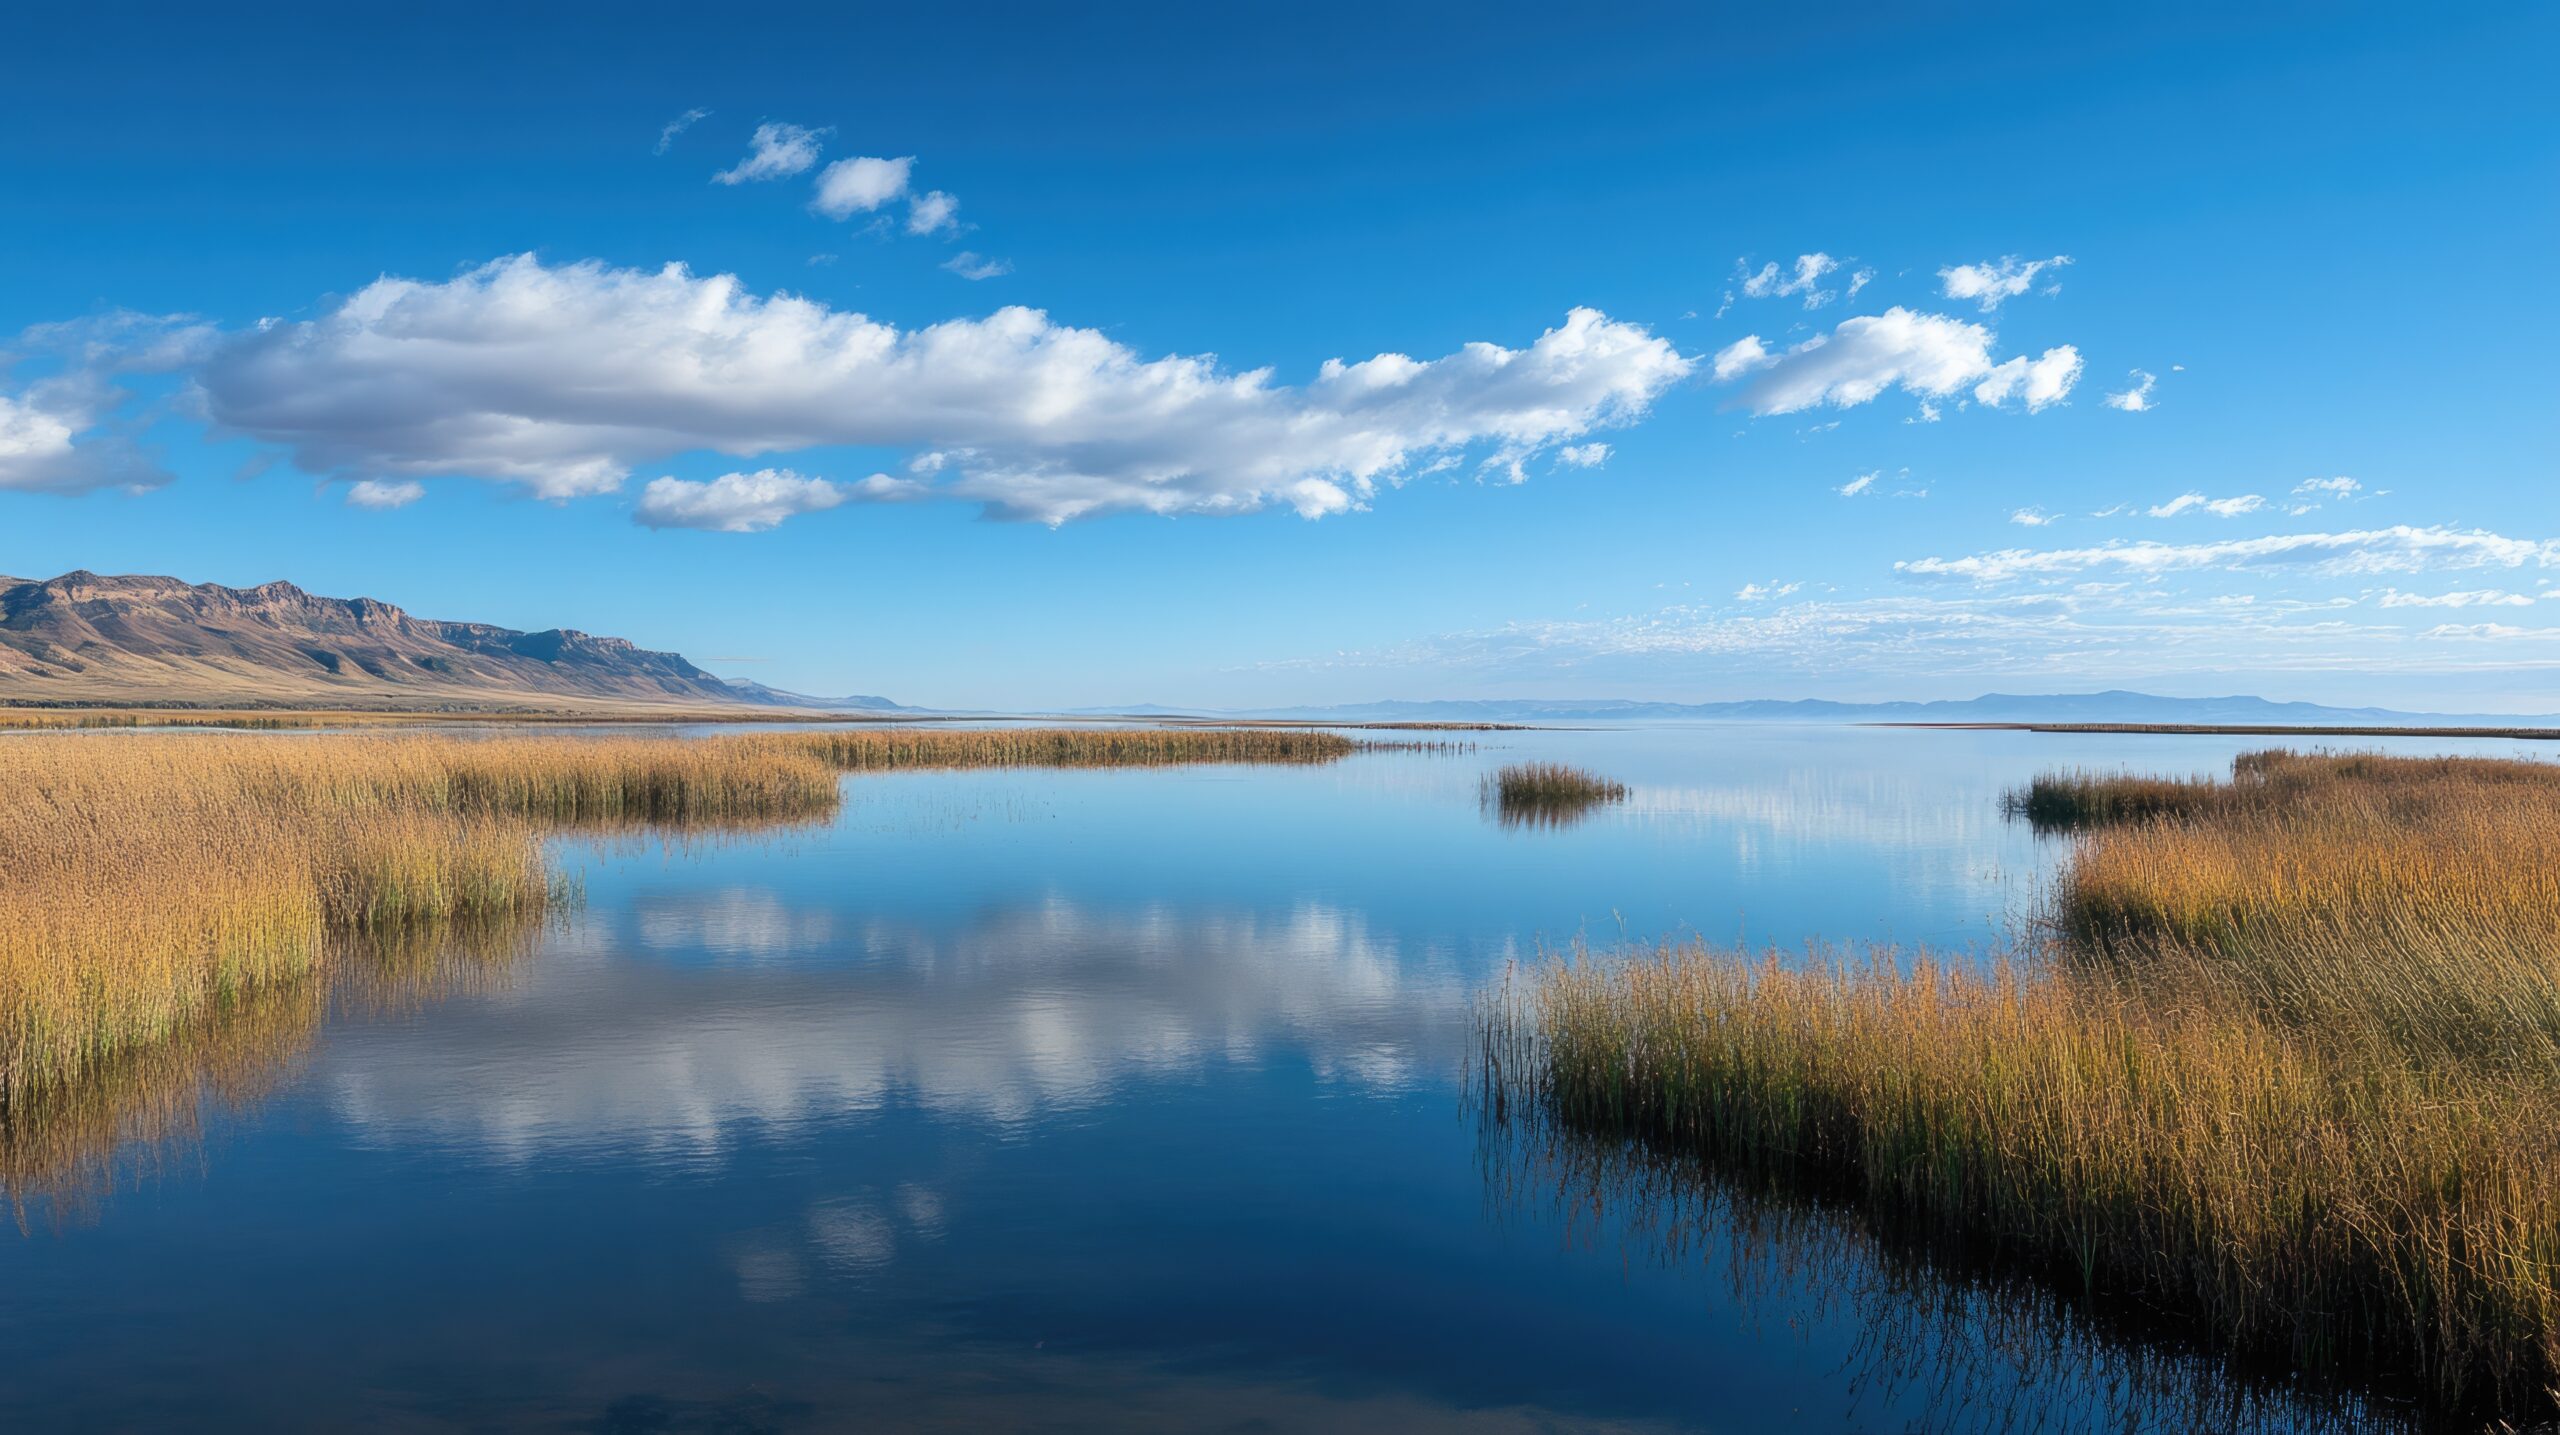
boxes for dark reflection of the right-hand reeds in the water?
[1472,1079,2424,1435]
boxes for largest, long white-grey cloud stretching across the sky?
[197,256,1697,524]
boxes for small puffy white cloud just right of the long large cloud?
[1713,304,2081,417]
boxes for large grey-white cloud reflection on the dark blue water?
[317,890,1469,1156]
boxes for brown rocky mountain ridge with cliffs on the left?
[0,573,875,711]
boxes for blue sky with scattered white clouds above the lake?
[0,5,2560,711]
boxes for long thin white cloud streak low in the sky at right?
[1894,524,2560,583]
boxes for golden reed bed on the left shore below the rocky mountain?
[0,729,1362,1123]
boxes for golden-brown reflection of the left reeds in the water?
[0,916,543,1230]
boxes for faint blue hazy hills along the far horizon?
[1075,691,2524,726]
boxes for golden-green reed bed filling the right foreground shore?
[1485,752,2560,1417]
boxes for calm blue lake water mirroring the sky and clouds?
[0,726,2516,1432]
